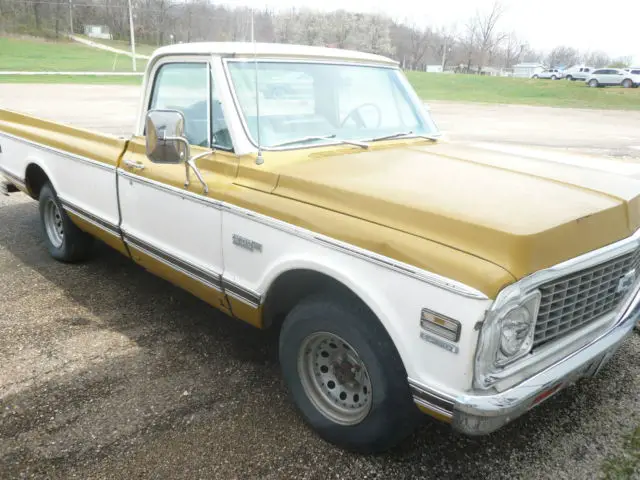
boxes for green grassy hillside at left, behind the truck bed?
[0,37,146,72]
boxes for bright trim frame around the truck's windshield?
[222,56,440,152]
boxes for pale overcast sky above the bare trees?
[219,0,640,64]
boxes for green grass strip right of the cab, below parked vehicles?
[407,72,640,110]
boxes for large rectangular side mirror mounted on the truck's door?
[145,110,190,164]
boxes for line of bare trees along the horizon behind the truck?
[0,0,630,73]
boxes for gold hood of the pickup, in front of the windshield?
[273,143,640,279]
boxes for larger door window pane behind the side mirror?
[149,63,209,147]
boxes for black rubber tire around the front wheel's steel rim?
[280,294,424,453]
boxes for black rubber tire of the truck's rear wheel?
[39,183,94,262]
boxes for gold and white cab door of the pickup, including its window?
[118,57,235,311]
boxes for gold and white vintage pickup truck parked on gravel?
[0,43,640,451]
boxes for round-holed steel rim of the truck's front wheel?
[298,332,373,425]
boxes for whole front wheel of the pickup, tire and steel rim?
[280,295,422,453]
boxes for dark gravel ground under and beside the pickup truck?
[0,86,640,480]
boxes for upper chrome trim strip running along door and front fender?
[118,168,489,300]
